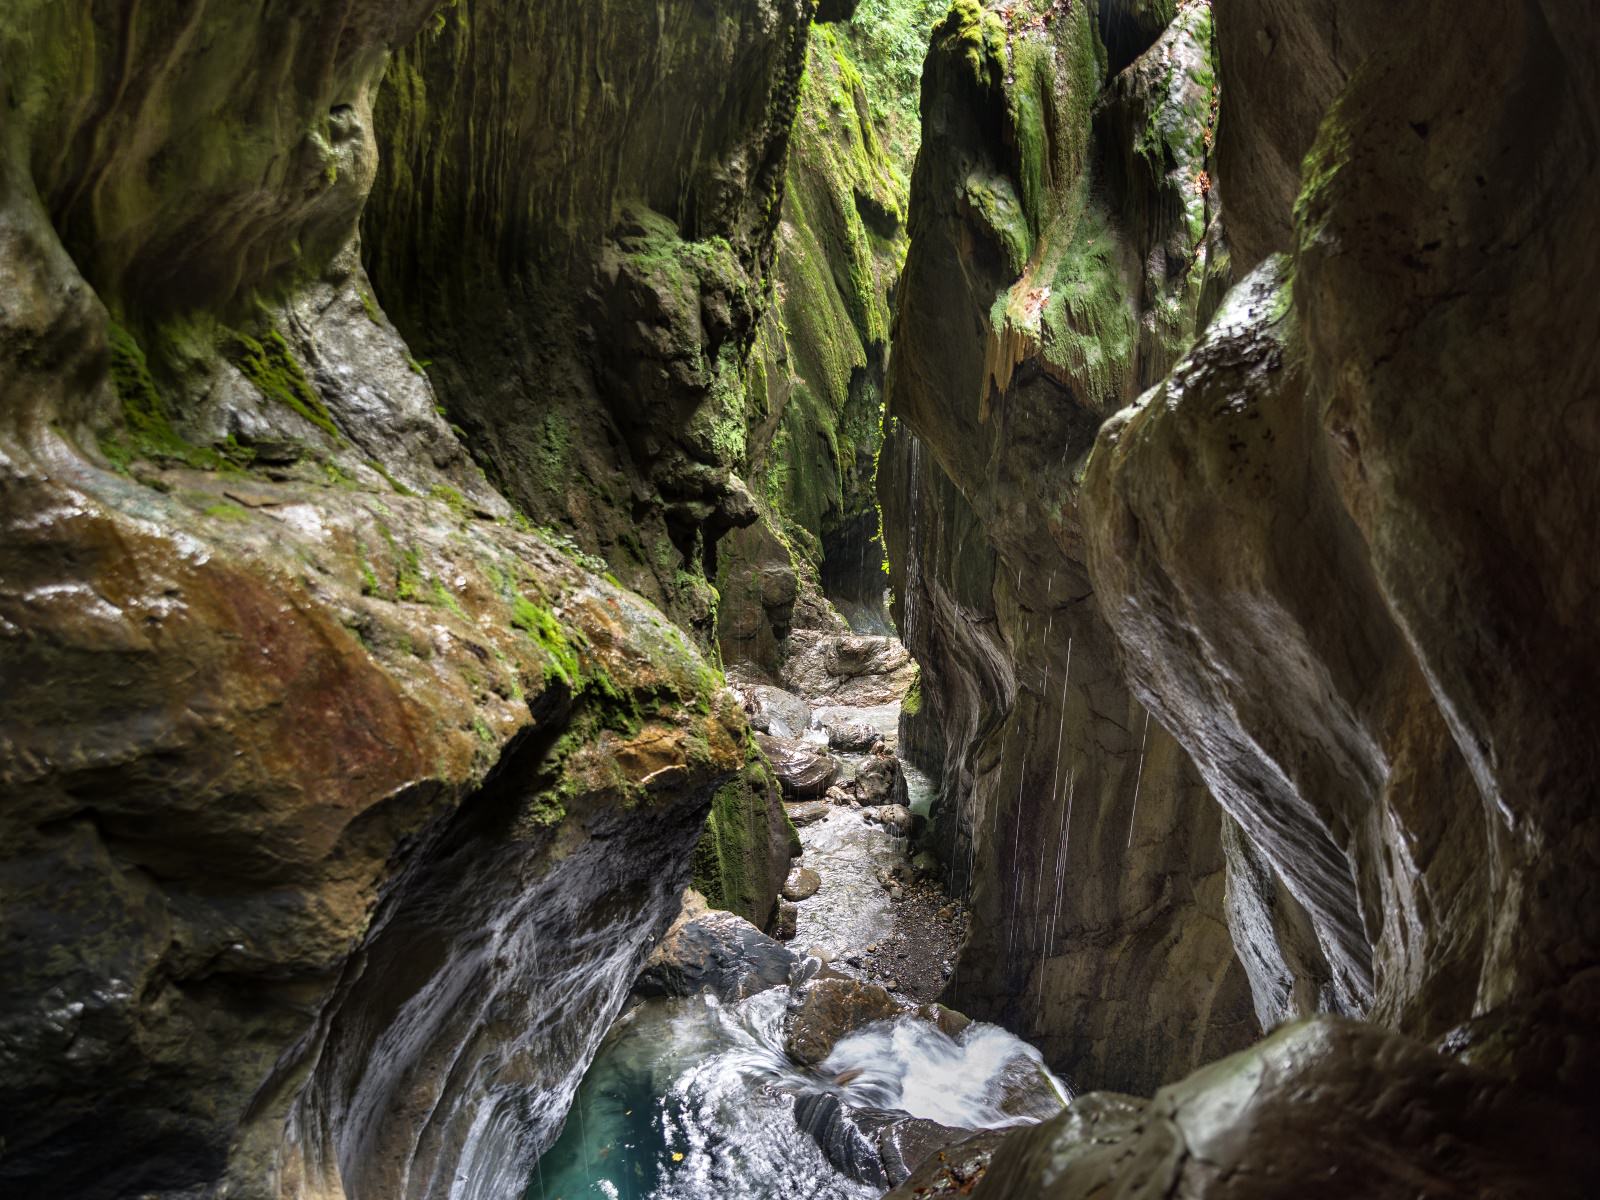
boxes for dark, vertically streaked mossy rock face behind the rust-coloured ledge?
[363,0,813,645]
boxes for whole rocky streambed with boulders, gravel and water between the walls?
[526,637,1069,1200]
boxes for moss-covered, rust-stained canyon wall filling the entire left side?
[0,0,810,1197]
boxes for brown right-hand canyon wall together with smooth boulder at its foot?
[896,0,1600,1200]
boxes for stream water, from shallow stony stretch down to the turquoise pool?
[525,672,1070,1200]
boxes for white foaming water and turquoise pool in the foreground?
[525,987,1067,1200]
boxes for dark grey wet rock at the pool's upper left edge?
[634,891,797,1003]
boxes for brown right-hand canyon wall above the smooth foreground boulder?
[1085,5,1600,1072]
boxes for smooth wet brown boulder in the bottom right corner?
[891,1018,1600,1200]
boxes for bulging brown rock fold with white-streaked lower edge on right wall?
[1086,259,1490,1034]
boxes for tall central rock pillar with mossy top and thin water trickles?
[878,2,1256,1090]
